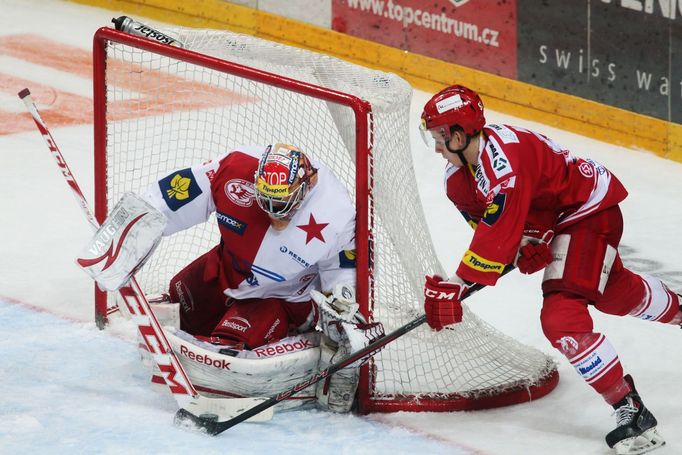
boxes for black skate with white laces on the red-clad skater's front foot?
[606,374,665,455]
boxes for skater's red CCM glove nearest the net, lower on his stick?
[424,275,471,331]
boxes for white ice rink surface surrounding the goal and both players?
[0,0,682,455]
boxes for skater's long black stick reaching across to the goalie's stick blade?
[175,265,515,435]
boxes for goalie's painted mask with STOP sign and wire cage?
[255,144,317,220]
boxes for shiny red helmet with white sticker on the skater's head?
[422,85,485,140]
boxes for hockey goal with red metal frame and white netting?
[93,28,558,413]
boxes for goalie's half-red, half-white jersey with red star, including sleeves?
[143,146,355,302]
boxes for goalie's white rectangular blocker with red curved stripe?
[76,193,167,291]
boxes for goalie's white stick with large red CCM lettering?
[19,88,272,420]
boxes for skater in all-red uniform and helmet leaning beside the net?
[421,85,682,454]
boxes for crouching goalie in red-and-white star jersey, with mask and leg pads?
[79,144,383,412]
